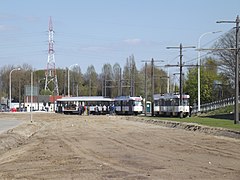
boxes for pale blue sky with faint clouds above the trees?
[0,0,240,73]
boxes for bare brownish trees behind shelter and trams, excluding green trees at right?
[0,55,167,102]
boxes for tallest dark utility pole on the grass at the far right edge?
[217,16,240,124]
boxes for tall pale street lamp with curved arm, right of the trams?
[197,31,222,112]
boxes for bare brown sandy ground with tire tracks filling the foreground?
[0,113,240,180]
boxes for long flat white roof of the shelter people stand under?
[57,96,112,102]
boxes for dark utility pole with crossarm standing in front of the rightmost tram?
[167,43,195,118]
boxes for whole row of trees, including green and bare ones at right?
[0,29,235,105]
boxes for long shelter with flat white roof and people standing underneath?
[56,96,112,114]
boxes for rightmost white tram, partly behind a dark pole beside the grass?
[154,93,190,117]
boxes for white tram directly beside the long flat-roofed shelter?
[114,96,143,115]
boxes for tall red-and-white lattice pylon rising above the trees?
[44,17,59,95]
